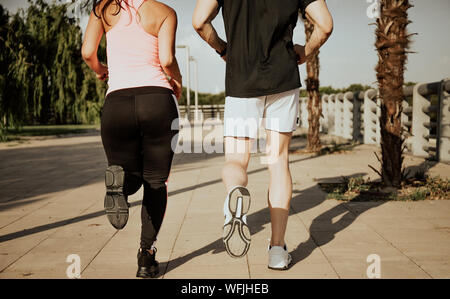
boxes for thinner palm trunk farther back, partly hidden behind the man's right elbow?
[304,19,322,152]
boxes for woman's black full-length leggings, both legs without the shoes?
[101,87,178,248]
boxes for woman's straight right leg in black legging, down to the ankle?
[136,94,178,249]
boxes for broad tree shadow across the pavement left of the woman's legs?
[0,142,106,211]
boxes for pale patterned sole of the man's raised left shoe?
[223,187,251,258]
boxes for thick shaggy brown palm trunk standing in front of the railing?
[375,0,412,188]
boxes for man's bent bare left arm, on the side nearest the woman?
[192,0,227,59]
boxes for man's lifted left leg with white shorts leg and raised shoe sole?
[222,97,264,257]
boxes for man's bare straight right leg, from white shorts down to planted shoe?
[266,130,292,246]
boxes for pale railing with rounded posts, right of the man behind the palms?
[300,79,450,162]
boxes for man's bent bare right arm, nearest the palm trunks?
[294,0,333,64]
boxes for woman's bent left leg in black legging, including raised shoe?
[101,92,142,229]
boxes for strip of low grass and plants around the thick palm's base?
[319,171,450,201]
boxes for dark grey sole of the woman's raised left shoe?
[104,165,129,229]
